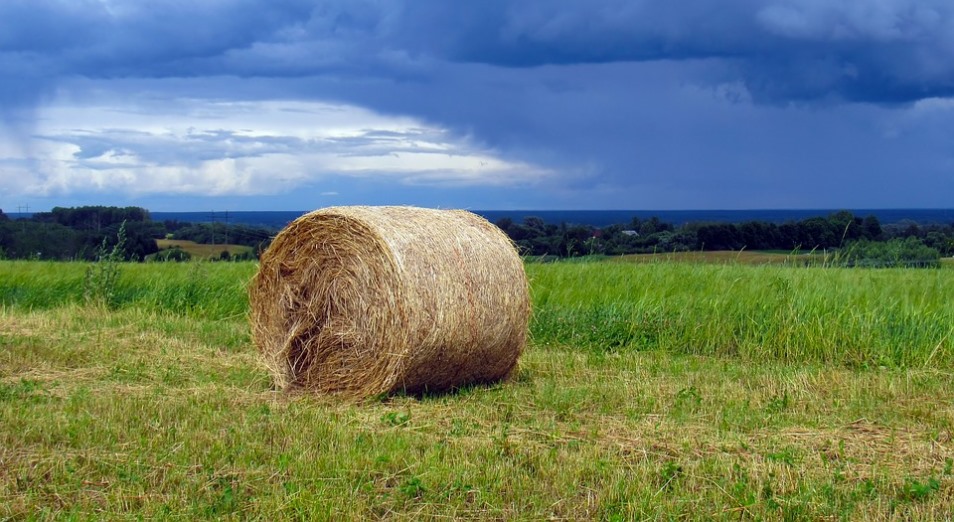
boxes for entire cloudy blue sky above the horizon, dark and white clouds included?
[0,0,954,212]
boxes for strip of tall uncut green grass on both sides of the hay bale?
[0,261,954,368]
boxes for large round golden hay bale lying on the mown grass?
[249,207,530,397]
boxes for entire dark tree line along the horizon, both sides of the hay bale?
[0,206,954,266]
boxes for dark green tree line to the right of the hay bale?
[496,207,954,266]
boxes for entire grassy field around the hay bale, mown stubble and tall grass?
[0,260,954,520]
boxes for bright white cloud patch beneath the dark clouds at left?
[11,90,549,196]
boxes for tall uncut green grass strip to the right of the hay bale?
[527,263,954,367]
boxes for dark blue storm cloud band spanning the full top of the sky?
[0,0,954,102]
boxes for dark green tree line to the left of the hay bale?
[0,206,275,261]
